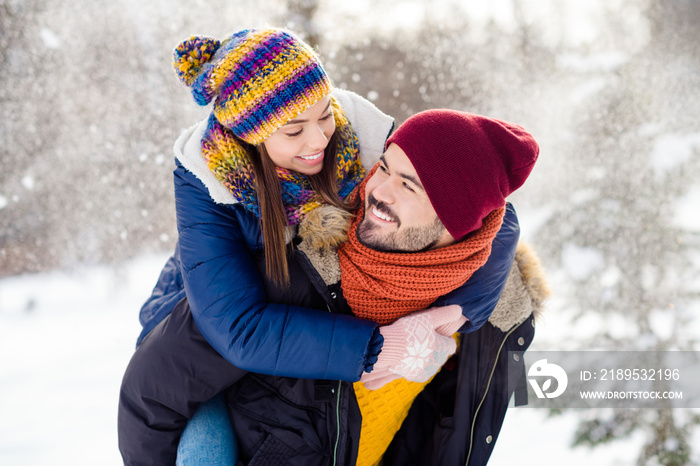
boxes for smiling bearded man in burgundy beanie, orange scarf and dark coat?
[120,110,538,465]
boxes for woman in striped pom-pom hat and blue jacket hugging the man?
[123,29,517,466]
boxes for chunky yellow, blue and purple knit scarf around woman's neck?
[202,98,365,225]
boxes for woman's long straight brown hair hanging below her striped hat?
[246,131,349,287]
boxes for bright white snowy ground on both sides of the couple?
[0,256,696,466]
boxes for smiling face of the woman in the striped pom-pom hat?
[263,97,335,175]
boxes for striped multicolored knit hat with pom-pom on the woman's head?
[173,29,331,144]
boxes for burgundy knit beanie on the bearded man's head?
[386,109,539,241]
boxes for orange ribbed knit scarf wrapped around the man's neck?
[338,168,505,324]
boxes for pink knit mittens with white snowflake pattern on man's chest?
[360,305,467,390]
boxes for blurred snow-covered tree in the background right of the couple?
[542,1,700,466]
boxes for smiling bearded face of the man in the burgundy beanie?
[357,144,454,252]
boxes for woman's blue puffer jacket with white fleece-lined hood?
[139,91,519,381]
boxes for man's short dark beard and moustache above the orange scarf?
[357,194,445,252]
